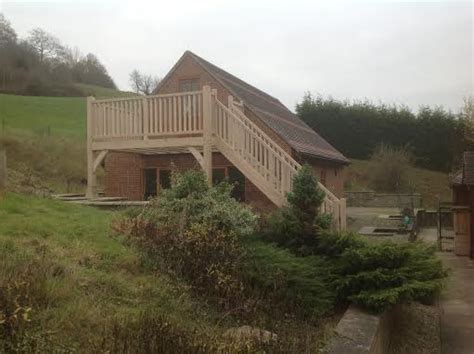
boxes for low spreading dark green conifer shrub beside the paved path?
[312,233,447,312]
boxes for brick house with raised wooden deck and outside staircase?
[87,51,349,227]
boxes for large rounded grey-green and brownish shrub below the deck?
[113,170,257,307]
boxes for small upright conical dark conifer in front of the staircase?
[263,165,331,254]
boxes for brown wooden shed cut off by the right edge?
[452,151,474,259]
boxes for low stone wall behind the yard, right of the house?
[345,192,422,208]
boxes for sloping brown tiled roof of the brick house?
[185,51,349,164]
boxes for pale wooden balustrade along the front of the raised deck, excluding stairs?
[91,91,203,141]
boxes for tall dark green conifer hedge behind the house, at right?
[296,93,472,172]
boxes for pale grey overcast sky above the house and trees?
[0,0,474,111]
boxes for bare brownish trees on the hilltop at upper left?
[0,13,116,96]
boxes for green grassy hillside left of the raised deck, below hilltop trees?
[0,84,133,195]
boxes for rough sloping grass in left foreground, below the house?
[0,194,222,351]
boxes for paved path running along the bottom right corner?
[439,253,474,354]
